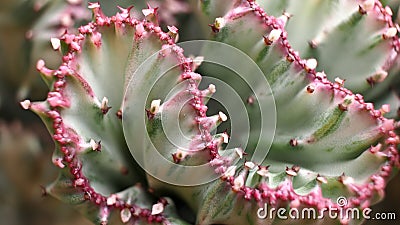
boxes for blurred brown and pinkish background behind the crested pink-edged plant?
[0,0,400,225]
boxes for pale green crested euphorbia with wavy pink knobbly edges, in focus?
[21,0,400,224]
